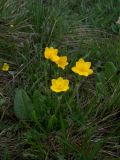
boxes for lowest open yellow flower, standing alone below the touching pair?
[50,77,69,93]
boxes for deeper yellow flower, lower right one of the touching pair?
[56,56,68,69]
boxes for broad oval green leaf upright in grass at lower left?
[14,89,33,120]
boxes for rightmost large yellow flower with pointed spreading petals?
[72,58,93,77]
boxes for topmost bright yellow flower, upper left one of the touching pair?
[44,47,58,60]
